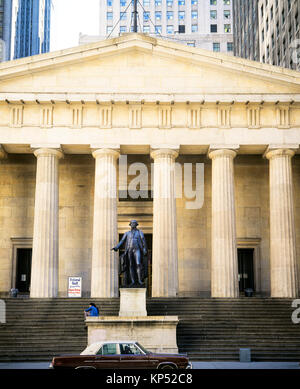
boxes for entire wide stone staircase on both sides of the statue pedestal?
[0,297,300,362]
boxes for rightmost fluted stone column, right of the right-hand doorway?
[266,149,298,298]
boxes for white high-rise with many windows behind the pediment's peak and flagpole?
[80,0,233,53]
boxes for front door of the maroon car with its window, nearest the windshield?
[119,342,152,369]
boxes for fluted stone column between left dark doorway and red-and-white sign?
[30,148,63,298]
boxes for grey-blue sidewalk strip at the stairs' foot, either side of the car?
[0,360,300,370]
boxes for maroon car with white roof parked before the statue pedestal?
[49,340,192,369]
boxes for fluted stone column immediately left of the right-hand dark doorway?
[209,149,239,297]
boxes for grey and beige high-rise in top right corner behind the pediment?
[233,0,300,70]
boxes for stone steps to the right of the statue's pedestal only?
[148,298,300,362]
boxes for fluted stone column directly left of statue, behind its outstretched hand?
[91,148,120,297]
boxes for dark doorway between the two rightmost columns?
[238,249,254,292]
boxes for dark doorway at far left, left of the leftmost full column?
[16,248,32,293]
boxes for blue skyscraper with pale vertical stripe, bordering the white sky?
[14,0,51,59]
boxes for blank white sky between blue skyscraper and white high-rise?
[50,0,99,51]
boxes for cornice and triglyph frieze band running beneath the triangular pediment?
[0,93,300,131]
